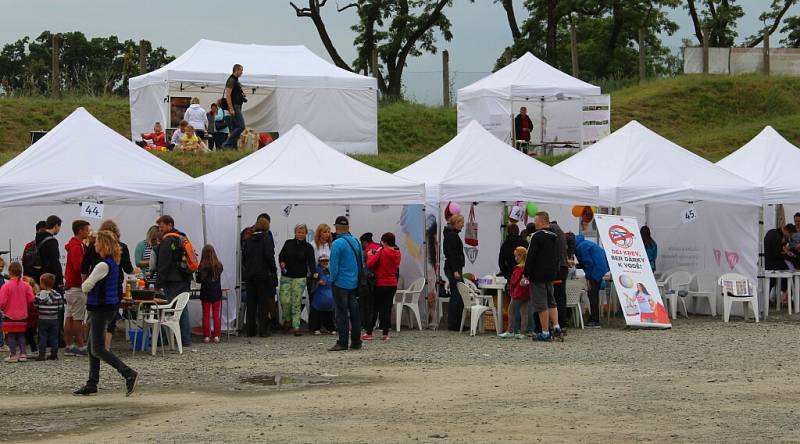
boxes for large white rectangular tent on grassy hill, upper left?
[129,40,378,154]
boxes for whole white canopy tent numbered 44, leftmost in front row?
[0,108,203,284]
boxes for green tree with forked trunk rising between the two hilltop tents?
[289,0,453,98]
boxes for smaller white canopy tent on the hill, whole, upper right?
[458,53,610,147]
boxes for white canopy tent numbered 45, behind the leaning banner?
[555,121,761,298]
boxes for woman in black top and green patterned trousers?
[278,224,319,336]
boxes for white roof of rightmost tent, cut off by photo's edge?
[717,126,800,204]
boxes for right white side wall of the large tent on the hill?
[275,88,378,154]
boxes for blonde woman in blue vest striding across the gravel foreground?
[74,230,139,396]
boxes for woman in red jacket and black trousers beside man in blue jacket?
[361,233,400,342]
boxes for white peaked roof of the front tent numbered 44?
[0,108,203,205]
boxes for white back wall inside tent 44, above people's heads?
[0,203,161,265]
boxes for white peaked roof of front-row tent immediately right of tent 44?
[199,125,425,205]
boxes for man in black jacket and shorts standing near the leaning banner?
[524,211,563,341]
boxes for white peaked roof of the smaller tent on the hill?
[458,52,600,100]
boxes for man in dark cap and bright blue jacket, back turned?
[330,216,364,351]
